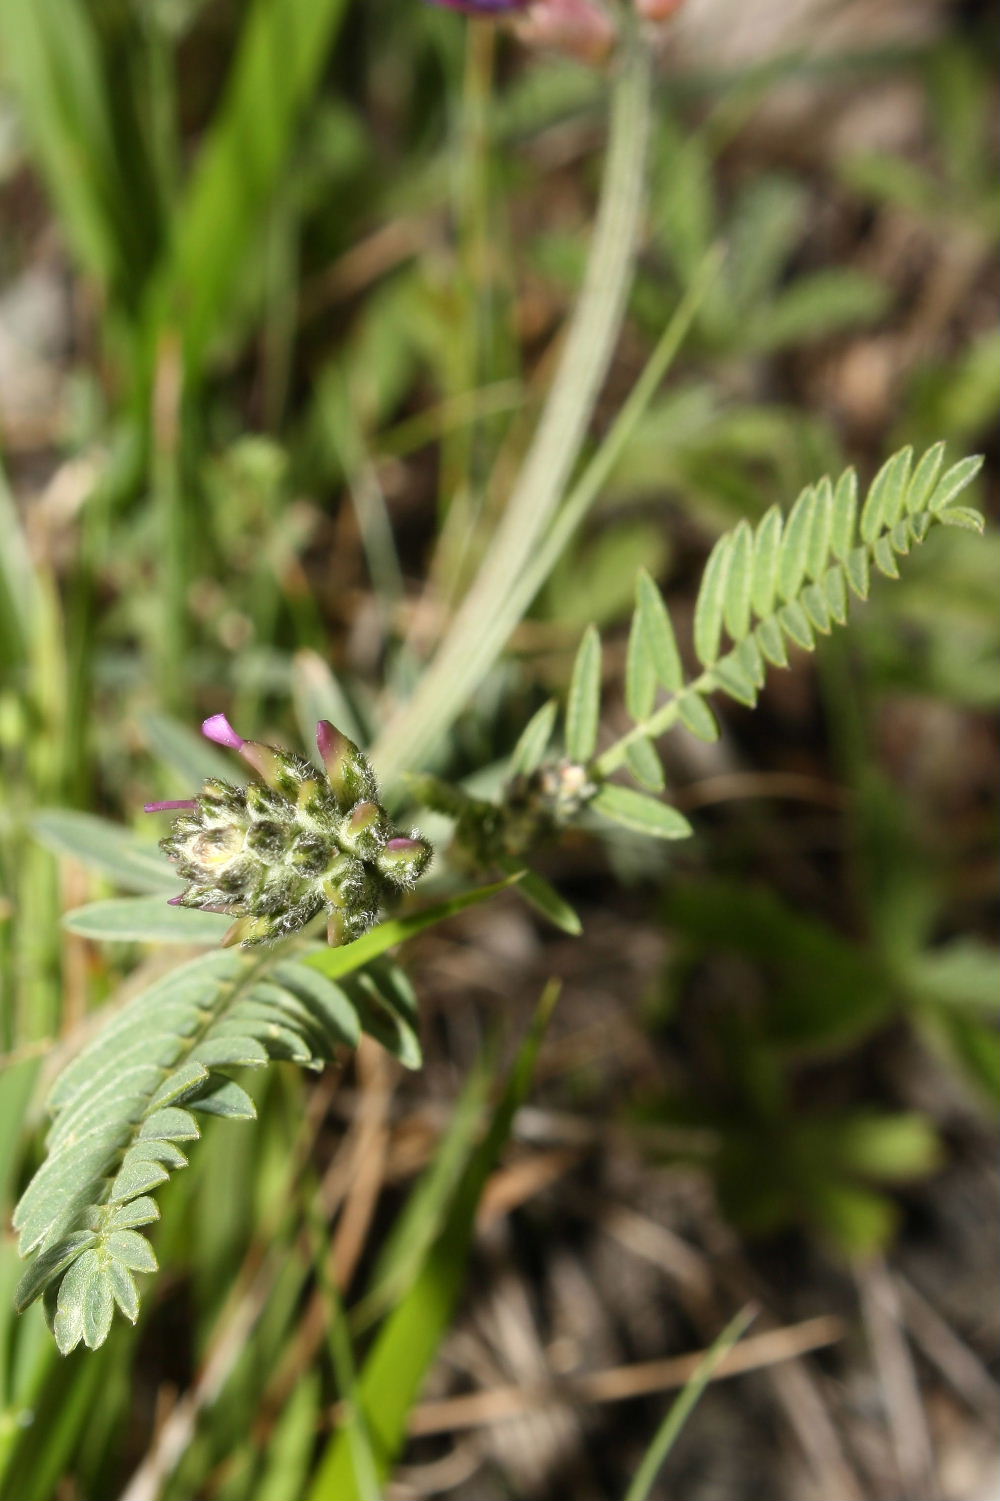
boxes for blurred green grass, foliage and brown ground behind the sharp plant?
[0,0,1000,1501]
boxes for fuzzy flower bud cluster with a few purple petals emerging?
[146,714,431,947]
